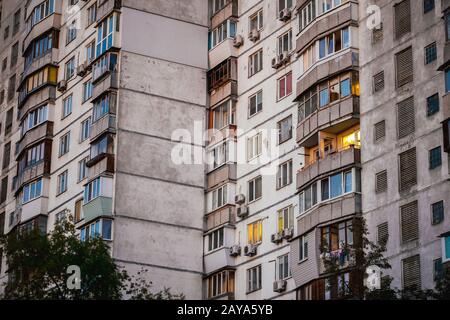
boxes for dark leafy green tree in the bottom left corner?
[0,218,184,300]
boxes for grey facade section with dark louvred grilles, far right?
[359,0,450,289]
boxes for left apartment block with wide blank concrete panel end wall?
[0,0,208,299]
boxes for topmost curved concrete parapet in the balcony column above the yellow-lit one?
[296,2,359,53]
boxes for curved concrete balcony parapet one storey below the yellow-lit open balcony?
[297,193,362,235]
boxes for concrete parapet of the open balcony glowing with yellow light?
[297,147,361,189]
